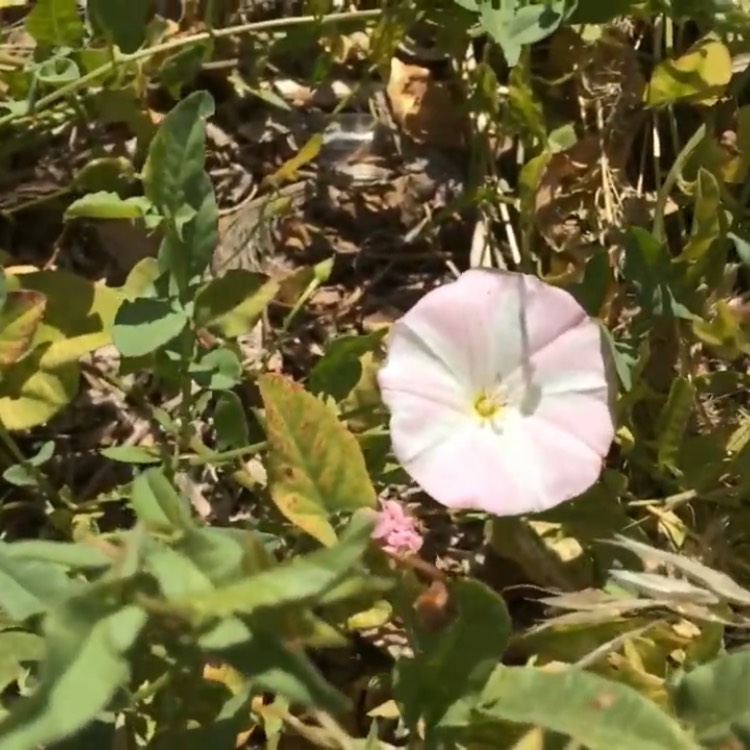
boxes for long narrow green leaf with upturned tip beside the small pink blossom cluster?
[175,516,372,619]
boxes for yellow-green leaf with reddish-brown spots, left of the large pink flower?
[258,374,376,545]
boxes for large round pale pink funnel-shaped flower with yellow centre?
[378,269,614,515]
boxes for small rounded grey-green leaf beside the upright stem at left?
[112,297,189,357]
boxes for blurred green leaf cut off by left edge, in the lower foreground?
[0,542,74,620]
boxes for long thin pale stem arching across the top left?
[0,10,382,126]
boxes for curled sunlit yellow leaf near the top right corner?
[645,37,732,107]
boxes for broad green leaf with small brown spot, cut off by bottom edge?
[474,666,699,750]
